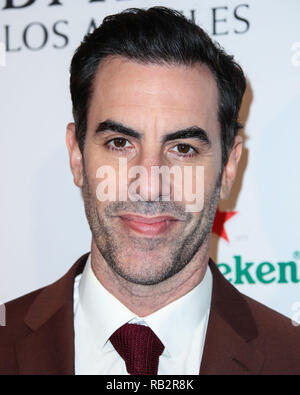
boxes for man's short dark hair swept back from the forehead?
[70,7,246,165]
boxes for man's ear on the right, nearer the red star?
[220,135,243,199]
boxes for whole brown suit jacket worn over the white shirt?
[0,254,300,375]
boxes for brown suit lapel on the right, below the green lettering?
[200,261,264,375]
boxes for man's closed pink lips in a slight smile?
[119,214,179,237]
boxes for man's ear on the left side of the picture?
[66,122,83,188]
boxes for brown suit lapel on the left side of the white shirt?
[15,254,88,375]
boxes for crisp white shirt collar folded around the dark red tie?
[79,255,212,357]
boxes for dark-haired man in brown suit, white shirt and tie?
[0,7,300,374]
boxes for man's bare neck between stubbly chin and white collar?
[91,238,210,317]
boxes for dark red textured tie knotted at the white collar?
[110,324,164,375]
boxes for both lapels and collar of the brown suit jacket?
[16,254,263,375]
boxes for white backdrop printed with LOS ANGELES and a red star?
[0,0,300,325]
